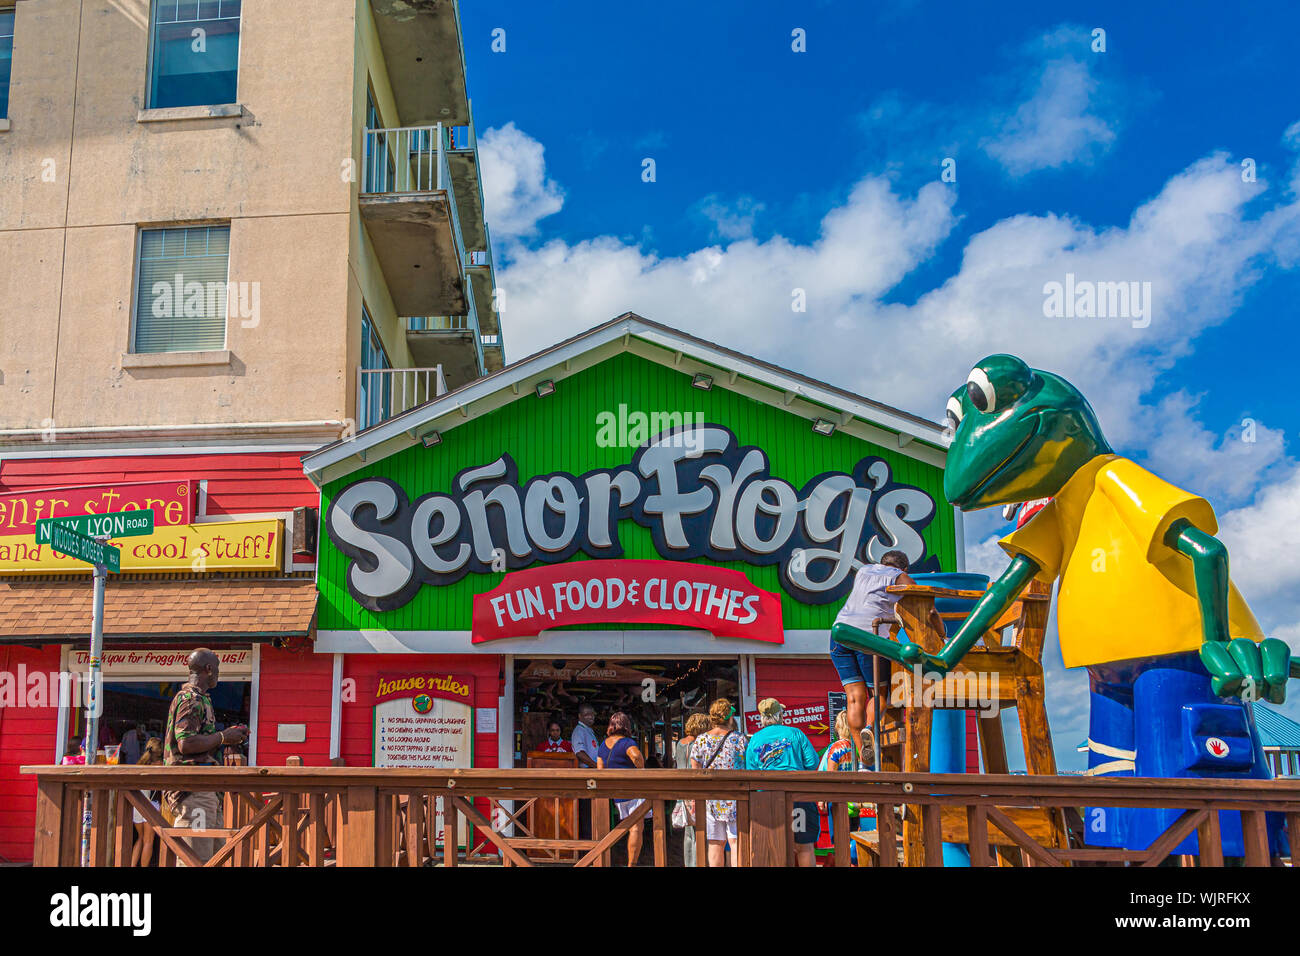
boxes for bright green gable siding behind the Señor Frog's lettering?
[317,351,957,631]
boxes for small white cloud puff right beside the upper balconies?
[478,122,564,239]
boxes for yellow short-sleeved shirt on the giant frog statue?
[998,455,1264,667]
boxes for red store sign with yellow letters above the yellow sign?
[0,479,195,536]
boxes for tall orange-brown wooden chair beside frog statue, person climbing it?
[876,581,1069,866]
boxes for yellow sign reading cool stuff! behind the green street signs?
[0,519,285,576]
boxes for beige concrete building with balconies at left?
[0,0,503,453]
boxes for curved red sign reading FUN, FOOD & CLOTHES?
[473,559,785,644]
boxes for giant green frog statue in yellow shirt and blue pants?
[832,355,1300,853]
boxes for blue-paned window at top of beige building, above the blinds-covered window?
[150,0,242,109]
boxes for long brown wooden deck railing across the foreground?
[23,766,1300,866]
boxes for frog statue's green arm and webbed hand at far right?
[1165,518,1300,704]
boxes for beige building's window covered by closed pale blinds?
[133,225,230,352]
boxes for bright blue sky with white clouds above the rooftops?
[462,0,1300,766]
